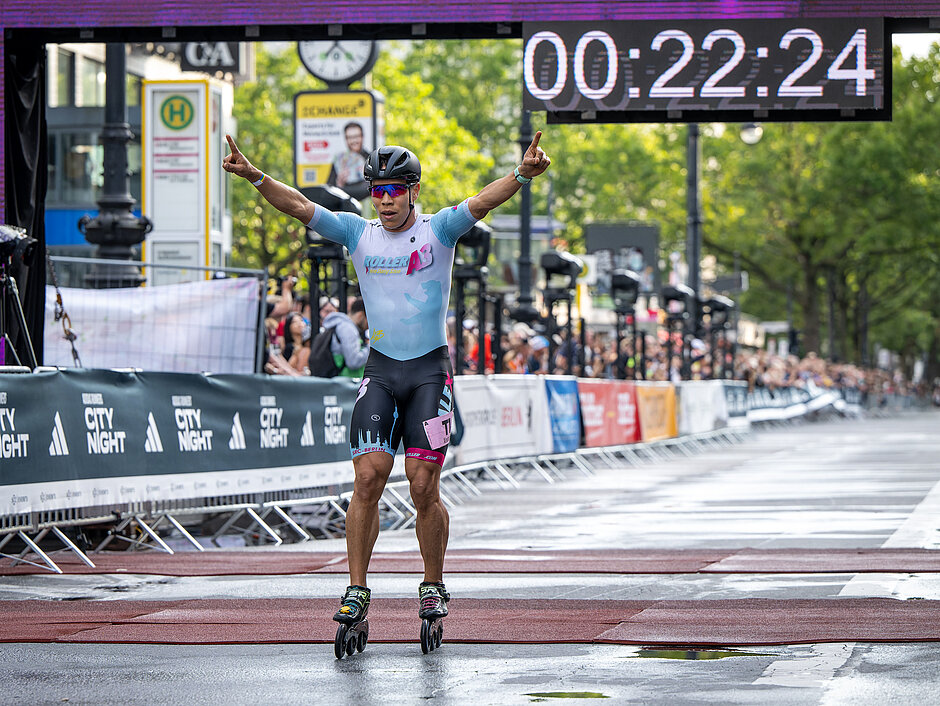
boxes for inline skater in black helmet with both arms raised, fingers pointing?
[222,132,551,657]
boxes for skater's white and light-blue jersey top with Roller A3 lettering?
[307,201,476,360]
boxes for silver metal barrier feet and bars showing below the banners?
[0,427,748,573]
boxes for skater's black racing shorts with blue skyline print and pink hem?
[349,346,454,465]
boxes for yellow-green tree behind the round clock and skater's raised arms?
[229,44,492,275]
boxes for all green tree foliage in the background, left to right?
[234,40,940,374]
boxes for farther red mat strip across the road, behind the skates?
[0,549,940,576]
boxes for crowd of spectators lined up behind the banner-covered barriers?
[265,277,940,406]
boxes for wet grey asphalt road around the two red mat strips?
[0,412,940,704]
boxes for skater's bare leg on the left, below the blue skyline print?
[346,451,394,586]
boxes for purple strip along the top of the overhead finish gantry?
[0,0,940,29]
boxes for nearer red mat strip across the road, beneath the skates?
[0,598,940,647]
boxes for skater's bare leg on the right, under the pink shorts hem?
[405,458,450,582]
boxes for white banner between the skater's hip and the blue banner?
[454,375,552,465]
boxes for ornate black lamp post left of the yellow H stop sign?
[78,44,153,289]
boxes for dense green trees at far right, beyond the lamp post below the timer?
[705,48,940,368]
